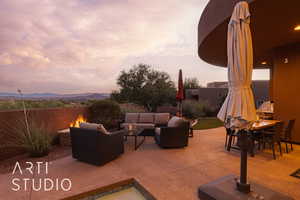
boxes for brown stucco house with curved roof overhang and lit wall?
[198,0,300,143]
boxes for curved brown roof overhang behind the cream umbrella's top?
[198,0,300,68]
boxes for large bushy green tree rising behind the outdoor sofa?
[111,64,176,111]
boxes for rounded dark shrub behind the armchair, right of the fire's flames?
[88,100,121,129]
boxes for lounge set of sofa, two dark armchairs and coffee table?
[70,113,190,165]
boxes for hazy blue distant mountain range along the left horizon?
[0,92,110,100]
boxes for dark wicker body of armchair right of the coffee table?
[154,121,190,148]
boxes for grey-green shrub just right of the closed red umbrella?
[182,100,204,119]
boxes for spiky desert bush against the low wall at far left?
[1,117,53,157]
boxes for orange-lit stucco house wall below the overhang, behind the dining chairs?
[270,43,300,143]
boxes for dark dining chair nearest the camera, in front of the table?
[262,122,284,160]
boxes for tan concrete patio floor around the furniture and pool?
[0,128,300,200]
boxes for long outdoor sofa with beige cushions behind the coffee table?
[120,113,170,136]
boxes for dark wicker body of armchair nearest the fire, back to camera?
[70,127,124,165]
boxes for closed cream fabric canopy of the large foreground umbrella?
[218,1,257,121]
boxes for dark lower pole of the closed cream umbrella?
[236,130,250,193]
